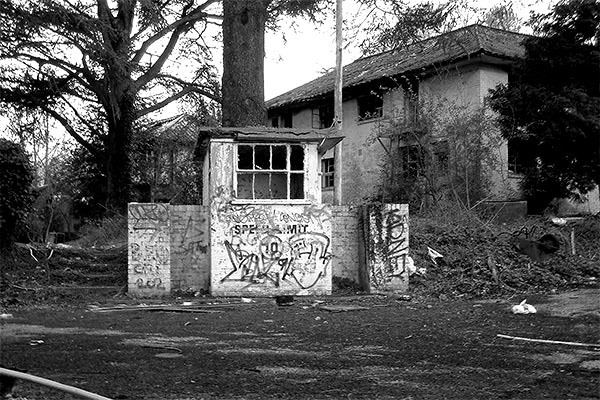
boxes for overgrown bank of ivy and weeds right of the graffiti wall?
[410,204,600,298]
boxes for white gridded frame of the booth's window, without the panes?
[233,142,308,204]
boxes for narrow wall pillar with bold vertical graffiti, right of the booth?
[367,204,410,292]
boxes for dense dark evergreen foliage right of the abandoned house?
[490,0,600,209]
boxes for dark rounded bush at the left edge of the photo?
[0,139,33,248]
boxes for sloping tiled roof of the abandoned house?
[266,25,527,109]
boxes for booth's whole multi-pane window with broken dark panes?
[236,144,304,200]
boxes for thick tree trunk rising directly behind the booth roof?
[222,0,269,126]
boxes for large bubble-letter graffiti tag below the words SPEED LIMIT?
[221,232,331,289]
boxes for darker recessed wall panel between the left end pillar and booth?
[169,205,210,292]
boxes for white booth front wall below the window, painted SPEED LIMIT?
[210,202,332,296]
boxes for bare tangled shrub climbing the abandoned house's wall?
[372,100,500,209]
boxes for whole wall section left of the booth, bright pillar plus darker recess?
[128,203,210,297]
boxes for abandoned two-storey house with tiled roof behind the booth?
[267,25,600,214]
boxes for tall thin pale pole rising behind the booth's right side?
[333,0,343,206]
